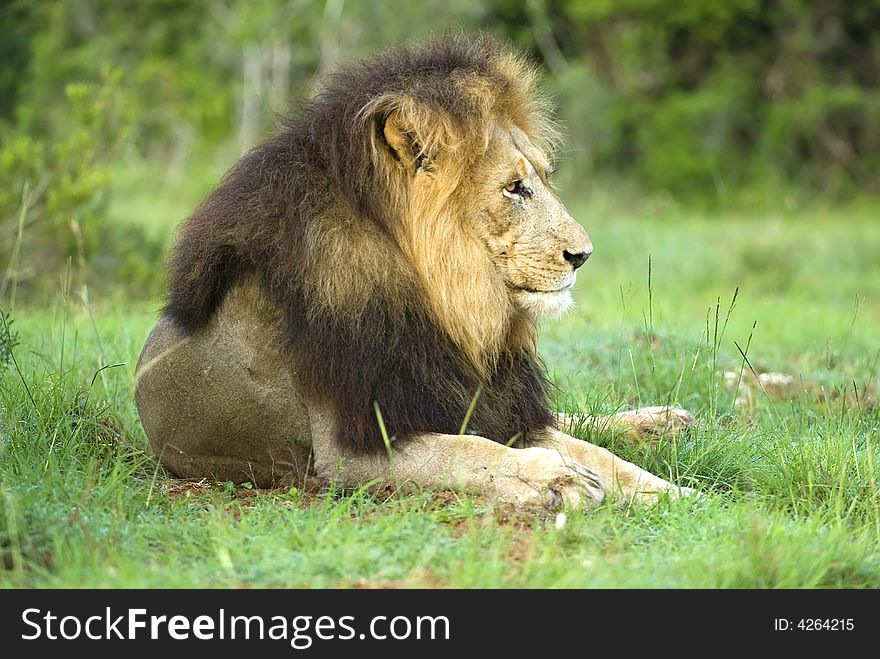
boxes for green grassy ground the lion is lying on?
[0,205,880,588]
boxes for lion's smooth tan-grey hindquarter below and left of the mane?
[135,280,311,487]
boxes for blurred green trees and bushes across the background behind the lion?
[0,0,880,300]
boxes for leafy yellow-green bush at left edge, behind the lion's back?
[0,67,159,298]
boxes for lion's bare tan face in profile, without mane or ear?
[467,126,593,316]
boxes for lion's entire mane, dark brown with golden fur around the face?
[165,37,551,451]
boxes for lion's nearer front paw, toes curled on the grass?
[497,447,605,510]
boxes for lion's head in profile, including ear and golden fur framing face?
[360,40,592,372]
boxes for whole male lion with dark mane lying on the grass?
[136,37,689,507]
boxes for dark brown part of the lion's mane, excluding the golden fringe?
[164,37,551,451]
